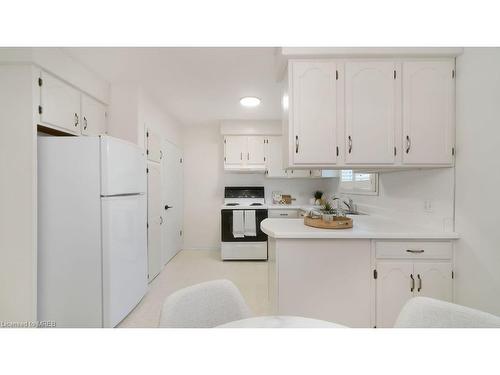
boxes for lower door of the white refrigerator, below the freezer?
[101,195,147,327]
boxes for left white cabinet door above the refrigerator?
[40,72,81,134]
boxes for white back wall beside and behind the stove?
[183,124,333,249]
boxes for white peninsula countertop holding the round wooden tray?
[260,215,459,240]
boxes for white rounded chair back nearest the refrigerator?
[160,280,252,328]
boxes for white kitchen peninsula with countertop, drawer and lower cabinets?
[261,215,458,327]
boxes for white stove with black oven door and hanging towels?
[221,186,267,260]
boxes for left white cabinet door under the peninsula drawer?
[376,261,416,328]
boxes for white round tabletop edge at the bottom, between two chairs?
[217,316,347,328]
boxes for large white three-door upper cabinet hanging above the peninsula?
[282,58,455,170]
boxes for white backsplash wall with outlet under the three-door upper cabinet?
[342,168,454,231]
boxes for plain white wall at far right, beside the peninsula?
[455,48,500,315]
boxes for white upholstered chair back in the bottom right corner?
[394,297,500,328]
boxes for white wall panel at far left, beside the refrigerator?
[0,65,39,322]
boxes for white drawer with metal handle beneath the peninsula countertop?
[375,241,453,259]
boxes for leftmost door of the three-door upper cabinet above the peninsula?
[289,60,337,165]
